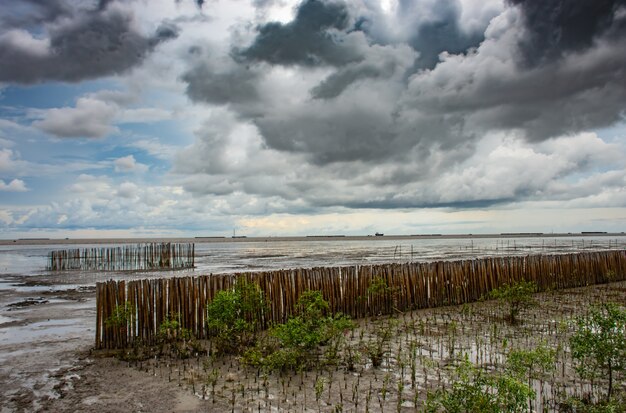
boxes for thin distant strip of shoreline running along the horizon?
[0,232,626,245]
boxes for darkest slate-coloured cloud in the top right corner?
[510,0,626,65]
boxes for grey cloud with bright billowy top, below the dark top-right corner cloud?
[405,30,626,141]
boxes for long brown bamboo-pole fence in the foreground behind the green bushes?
[96,250,626,349]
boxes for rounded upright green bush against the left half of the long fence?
[206,278,266,354]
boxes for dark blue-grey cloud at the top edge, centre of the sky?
[236,0,360,66]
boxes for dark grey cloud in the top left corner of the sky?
[0,2,178,84]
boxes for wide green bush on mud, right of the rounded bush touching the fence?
[243,291,354,370]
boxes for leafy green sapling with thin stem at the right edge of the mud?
[570,303,626,400]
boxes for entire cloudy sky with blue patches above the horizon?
[0,0,626,239]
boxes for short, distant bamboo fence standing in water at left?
[47,242,195,271]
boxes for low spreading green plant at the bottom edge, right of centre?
[424,359,535,413]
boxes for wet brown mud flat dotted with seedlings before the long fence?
[0,282,626,412]
